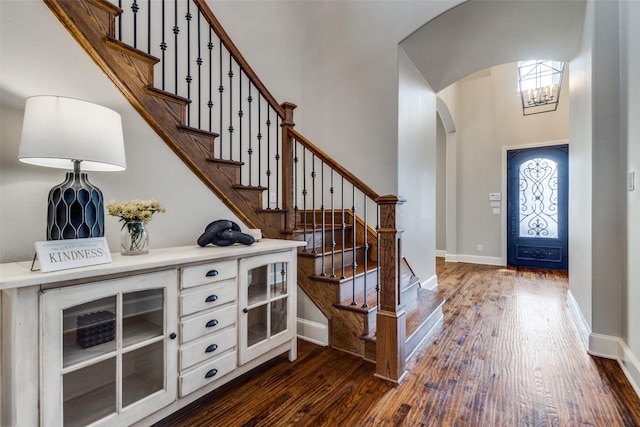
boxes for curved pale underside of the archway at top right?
[400,0,586,92]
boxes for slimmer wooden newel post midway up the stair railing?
[280,102,296,234]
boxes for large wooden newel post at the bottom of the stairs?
[376,195,406,383]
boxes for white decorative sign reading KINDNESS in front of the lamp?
[36,237,111,273]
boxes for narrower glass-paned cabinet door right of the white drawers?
[240,253,295,364]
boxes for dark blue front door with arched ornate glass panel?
[507,144,569,269]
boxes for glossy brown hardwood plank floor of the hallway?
[158,260,640,427]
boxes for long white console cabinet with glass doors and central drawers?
[0,240,304,426]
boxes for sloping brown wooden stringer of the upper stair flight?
[45,0,284,238]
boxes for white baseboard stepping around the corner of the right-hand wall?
[567,290,640,397]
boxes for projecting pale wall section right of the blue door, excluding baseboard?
[569,1,625,344]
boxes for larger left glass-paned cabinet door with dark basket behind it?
[41,271,177,426]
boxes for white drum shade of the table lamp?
[18,96,127,171]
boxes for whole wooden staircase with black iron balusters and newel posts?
[44,0,444,382]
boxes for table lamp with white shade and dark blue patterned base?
[18,96,126,240]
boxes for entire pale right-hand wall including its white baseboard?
[569,1,640,394]
